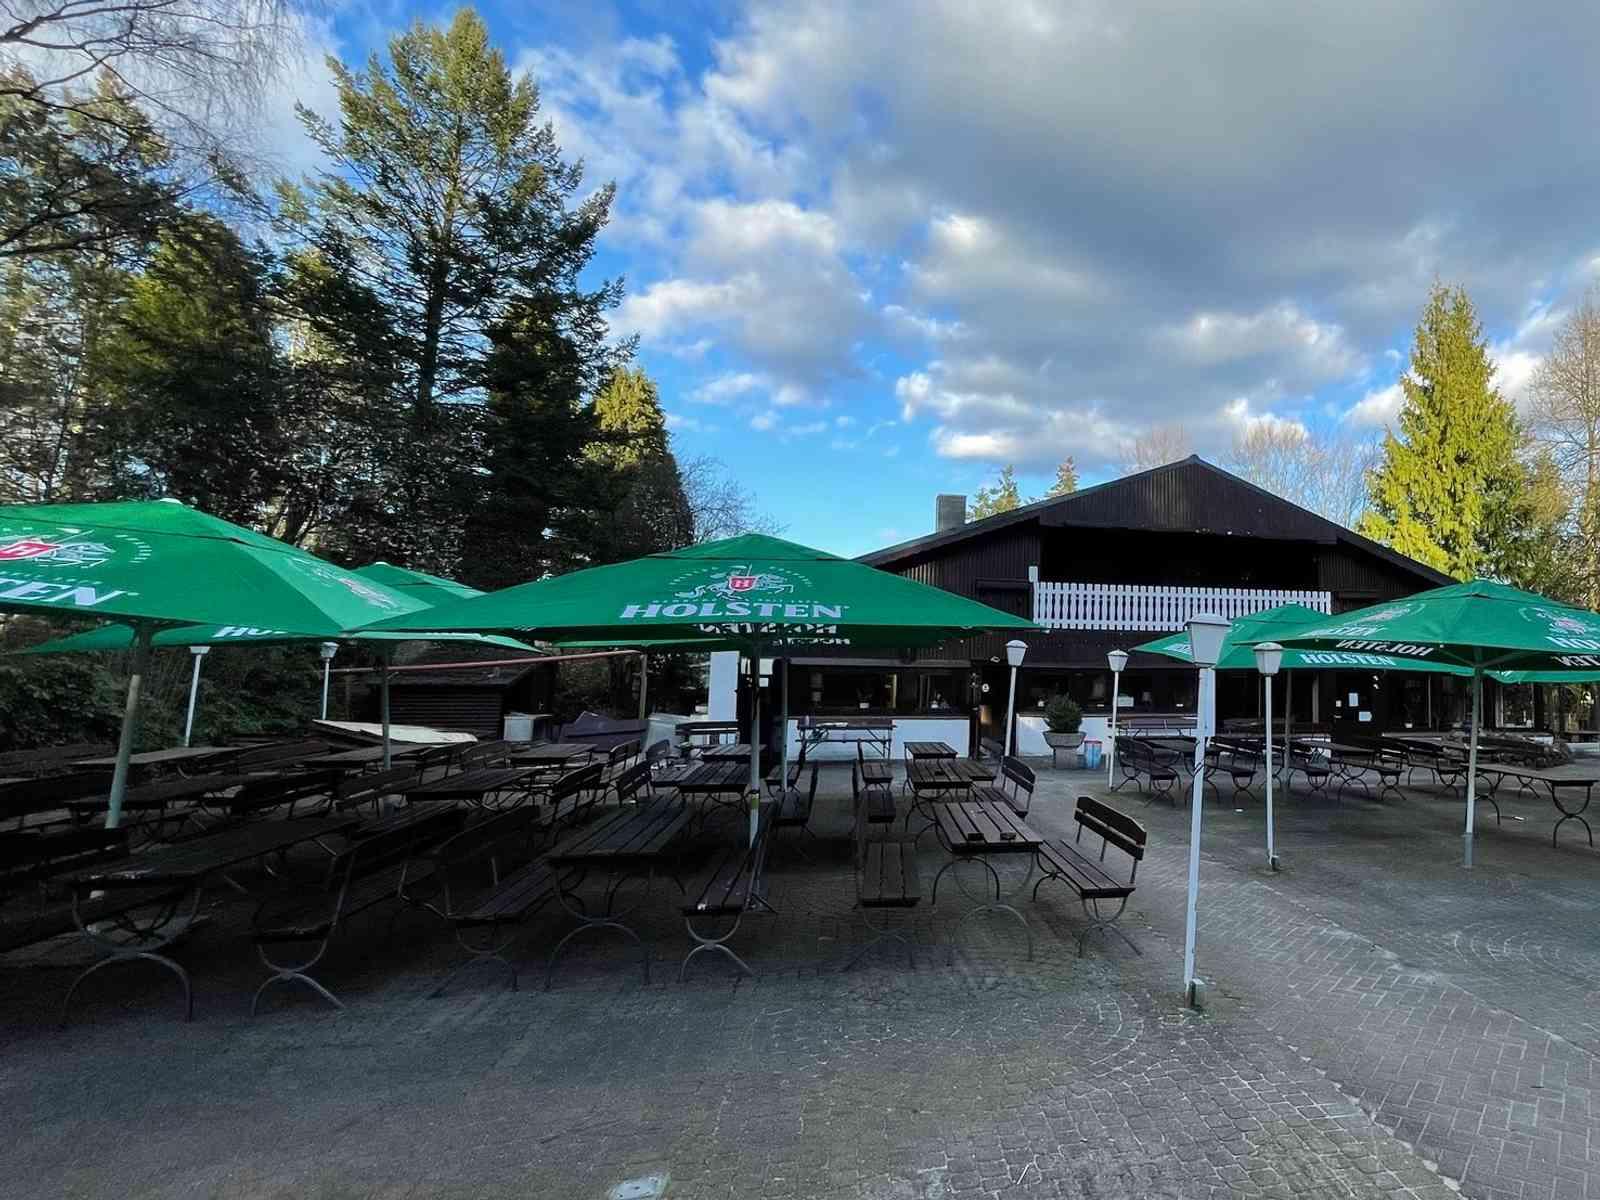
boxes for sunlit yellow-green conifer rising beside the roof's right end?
[1357,283,1526,579]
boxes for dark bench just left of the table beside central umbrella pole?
[427,806,555,995]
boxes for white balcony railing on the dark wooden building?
[1034,582,1333,634]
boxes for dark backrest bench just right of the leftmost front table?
[250,805,461,1016]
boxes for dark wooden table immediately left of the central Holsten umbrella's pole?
[544,800,690,989]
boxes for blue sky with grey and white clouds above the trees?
[268,0,1600,554]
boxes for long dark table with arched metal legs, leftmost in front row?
[61,816,360,1021]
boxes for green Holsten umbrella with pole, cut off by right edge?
[1277,579,1600,866]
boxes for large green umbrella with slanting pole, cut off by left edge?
[0,501,426,827]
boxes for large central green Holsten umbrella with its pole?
[363,534,1038,830]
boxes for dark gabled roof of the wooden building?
[861,454,1454,586]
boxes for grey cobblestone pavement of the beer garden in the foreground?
[0,771,1600,1200]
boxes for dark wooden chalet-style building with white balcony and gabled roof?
[790,458,1504,752]
